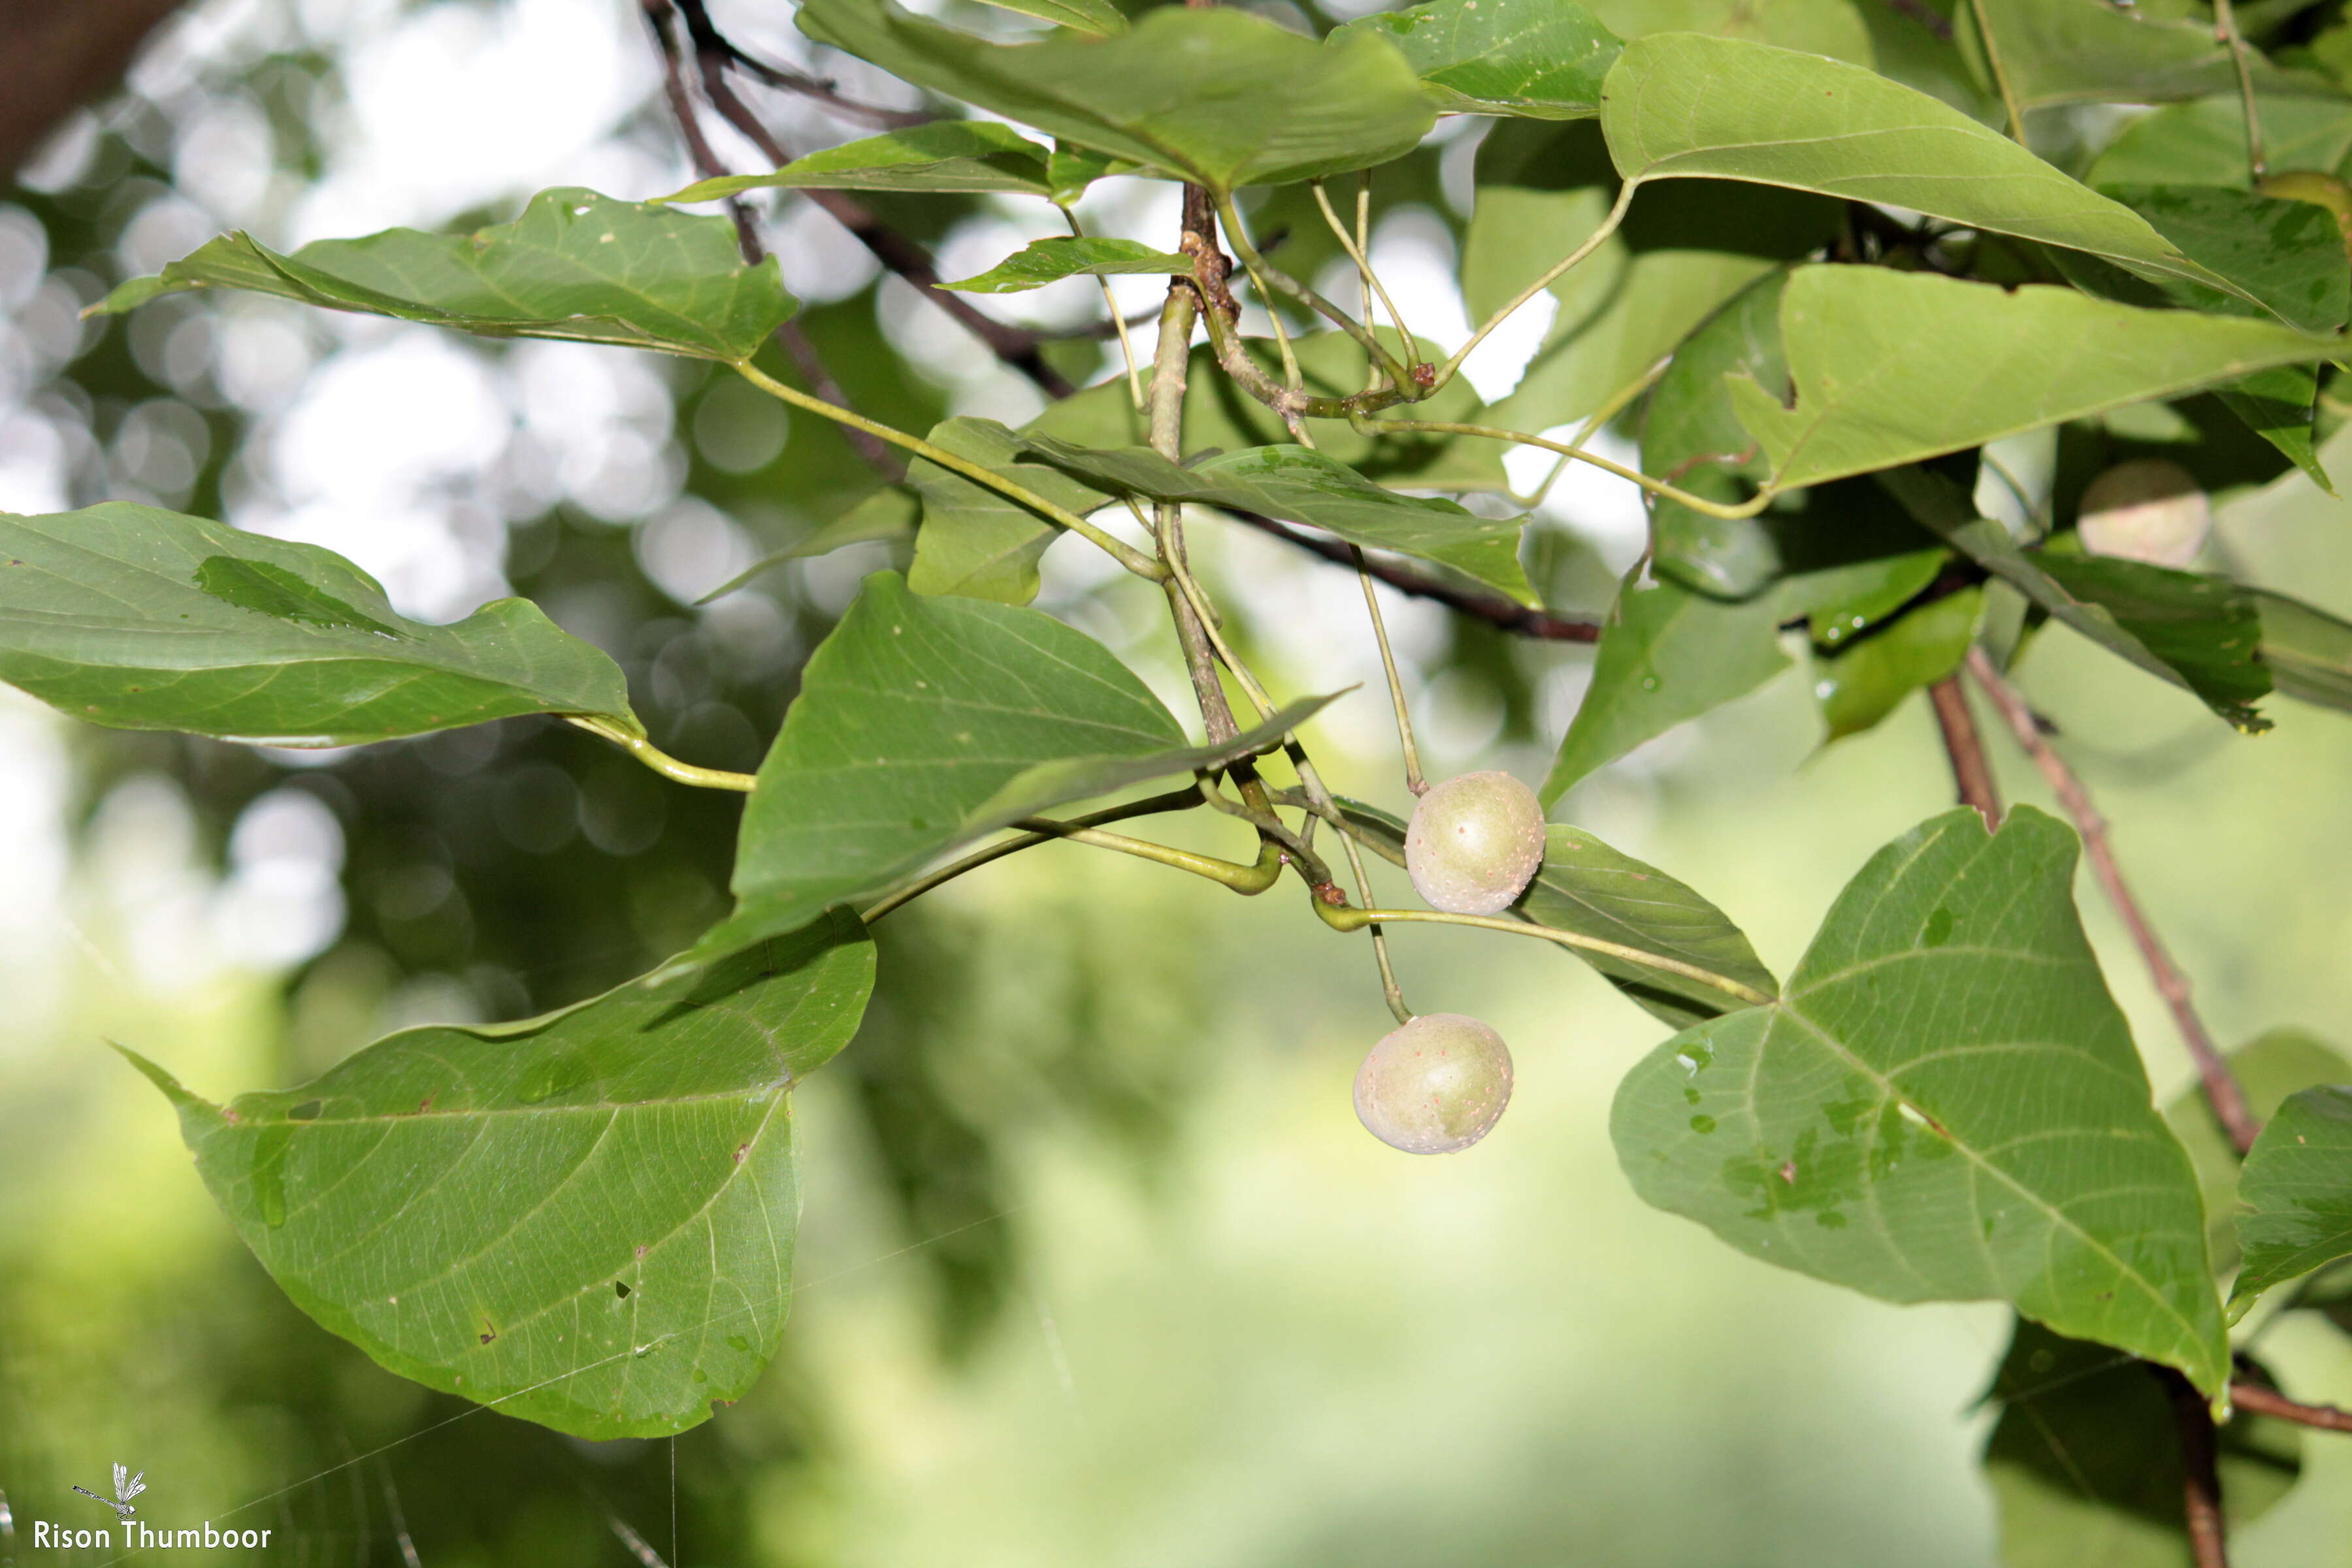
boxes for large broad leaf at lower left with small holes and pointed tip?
[132,915,873,1439]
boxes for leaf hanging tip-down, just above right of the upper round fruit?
[1538,581,1788,806]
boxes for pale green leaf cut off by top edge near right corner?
[1955,0,2328,108]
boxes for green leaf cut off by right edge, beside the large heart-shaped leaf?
[2230,1084,2352,1319]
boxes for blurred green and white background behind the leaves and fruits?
[14,0,2352,1568]
